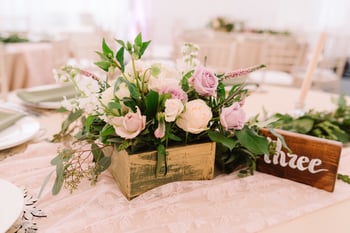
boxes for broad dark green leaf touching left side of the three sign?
[236,126,269,155]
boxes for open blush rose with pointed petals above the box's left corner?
[109,109,146,139]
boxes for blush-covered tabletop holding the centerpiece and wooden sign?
[0,86,350,233]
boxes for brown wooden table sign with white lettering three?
[257,129,342,192]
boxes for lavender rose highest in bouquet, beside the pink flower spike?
[188,66,219,96]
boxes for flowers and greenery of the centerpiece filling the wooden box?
[52,34,269,197]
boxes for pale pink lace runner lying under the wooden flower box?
[0,142,350,233]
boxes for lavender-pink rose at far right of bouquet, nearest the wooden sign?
[220,102,245,130]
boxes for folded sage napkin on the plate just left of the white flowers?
[17,85,78,104]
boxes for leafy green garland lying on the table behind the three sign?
[271,95,350,184]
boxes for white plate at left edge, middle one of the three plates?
[0,116,40,151]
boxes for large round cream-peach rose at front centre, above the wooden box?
[176,99,213,134]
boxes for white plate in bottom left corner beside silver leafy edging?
[0,179,24,232]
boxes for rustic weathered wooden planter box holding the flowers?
[109,142,215,200]
